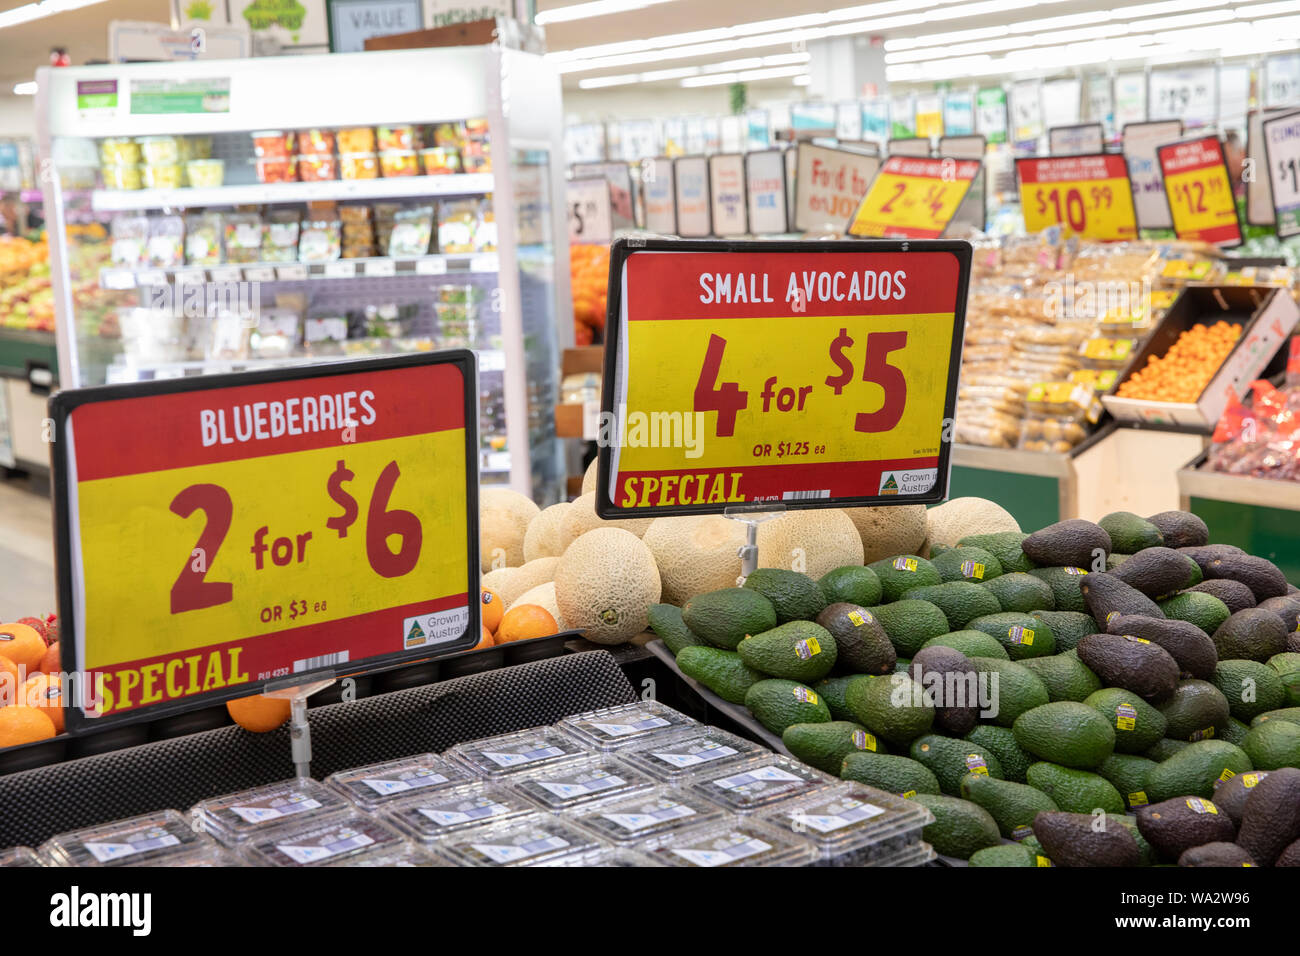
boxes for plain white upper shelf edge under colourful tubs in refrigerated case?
[91,173,493,212]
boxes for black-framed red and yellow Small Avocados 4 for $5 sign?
[595,239,971,518]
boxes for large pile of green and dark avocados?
[649,511,1300,866]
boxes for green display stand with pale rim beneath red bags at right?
[1178,453,1300,580]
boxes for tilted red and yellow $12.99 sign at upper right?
[1156,137,1242,246]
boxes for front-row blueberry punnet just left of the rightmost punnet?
[637,817,816,866]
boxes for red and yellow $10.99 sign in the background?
[1015,153,1138,241]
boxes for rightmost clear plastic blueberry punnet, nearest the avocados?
[762,783,933,865]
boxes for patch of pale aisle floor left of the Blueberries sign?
[0,480,55,620]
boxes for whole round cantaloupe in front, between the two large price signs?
[555,528,662,644]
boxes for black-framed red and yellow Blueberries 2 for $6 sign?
[51,351,478,731]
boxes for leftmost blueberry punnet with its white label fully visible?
[40,810,212,866]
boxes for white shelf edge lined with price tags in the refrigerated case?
[99,252,501,290]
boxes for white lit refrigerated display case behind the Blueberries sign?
[36,47,573,503]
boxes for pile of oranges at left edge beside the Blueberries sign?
[0,618,64,748]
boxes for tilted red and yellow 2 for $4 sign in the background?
[849,156,980,239]
